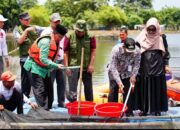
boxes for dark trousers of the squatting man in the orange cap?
[0,89,23,114]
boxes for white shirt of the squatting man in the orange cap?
[0,81,31,103]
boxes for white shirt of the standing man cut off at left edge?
[0,29,8,57]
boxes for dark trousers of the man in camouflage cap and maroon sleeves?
[67,69,93,101]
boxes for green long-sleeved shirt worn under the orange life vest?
[24,38,58,78]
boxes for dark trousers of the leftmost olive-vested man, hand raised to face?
[20,61,31,98]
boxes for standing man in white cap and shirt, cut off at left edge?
[0,14,9,75]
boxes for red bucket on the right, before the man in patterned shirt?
[95,102,128,117]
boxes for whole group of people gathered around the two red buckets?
[0,12,170,116]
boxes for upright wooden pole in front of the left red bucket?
[78,48,84,115]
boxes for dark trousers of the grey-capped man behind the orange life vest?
[51,62,65,105]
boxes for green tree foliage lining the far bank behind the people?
[0,0,180,30]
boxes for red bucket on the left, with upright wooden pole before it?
[66,101,96,116]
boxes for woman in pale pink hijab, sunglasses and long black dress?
[135,18,168,116]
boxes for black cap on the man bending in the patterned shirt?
[124,38,136,52]
